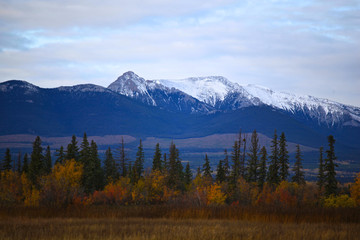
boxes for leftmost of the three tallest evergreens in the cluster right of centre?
[247,130,260,182]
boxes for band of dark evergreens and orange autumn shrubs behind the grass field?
[0,130,360,208]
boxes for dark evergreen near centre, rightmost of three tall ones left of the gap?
[168,142,183,189]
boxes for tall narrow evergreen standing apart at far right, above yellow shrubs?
[324,135,338,196]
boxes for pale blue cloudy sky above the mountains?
[0,0,360,106]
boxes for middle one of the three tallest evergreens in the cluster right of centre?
[267,129,280,184]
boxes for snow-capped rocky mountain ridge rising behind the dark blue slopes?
[108,72,360,127]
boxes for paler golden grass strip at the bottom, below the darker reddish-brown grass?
[0,217,360,240]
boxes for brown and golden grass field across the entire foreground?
[0,206,360,240]
